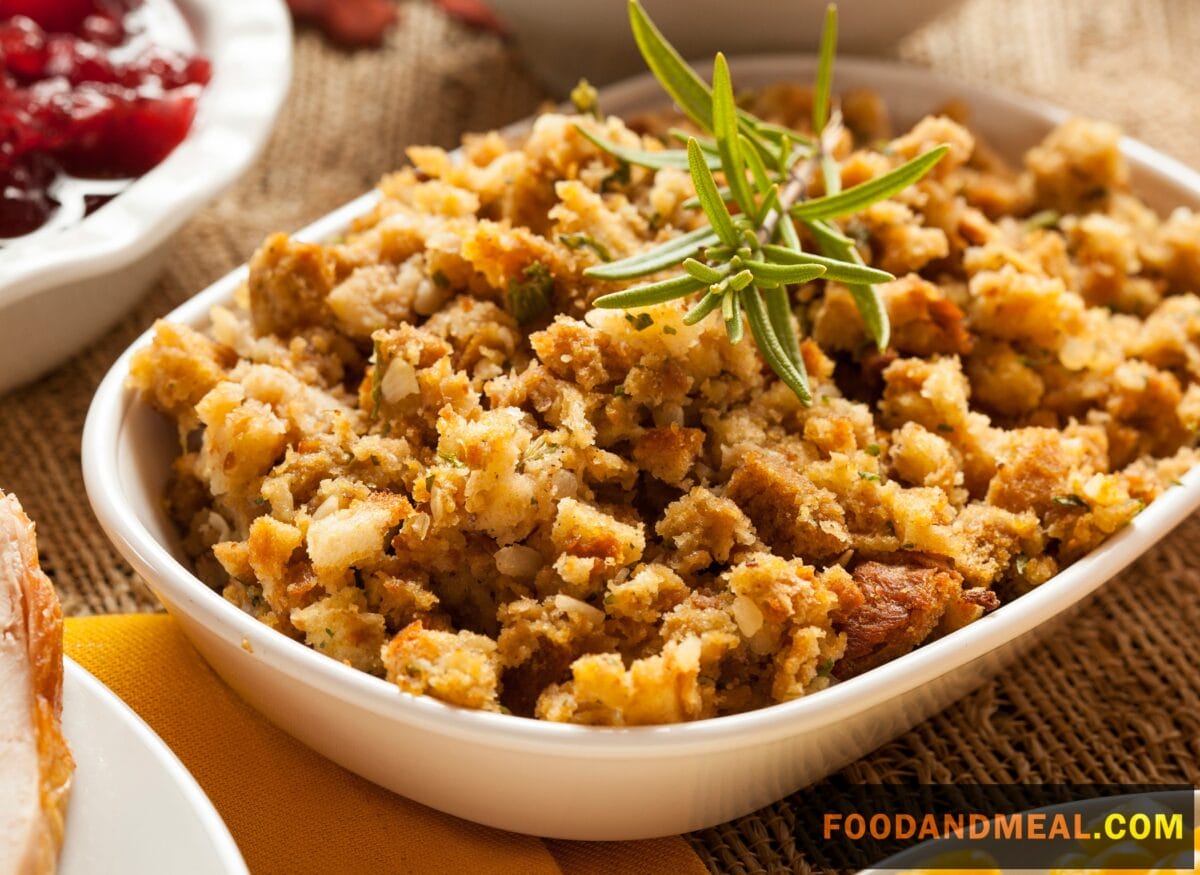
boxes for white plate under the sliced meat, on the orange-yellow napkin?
[59,659,248,875]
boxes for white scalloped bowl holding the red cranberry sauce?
[0,0,292,392]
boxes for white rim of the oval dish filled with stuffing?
[83,55,1200,760]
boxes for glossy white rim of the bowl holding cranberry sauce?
[0,0,292,307]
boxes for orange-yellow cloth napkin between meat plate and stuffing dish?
[66,615,707,875]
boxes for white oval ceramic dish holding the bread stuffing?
[83,58,1200,839]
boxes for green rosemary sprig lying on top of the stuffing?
[576,0,947,404]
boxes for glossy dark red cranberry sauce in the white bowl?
[0,0,211,239]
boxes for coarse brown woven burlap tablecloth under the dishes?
[0,0,1200,873]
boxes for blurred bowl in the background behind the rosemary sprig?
[488,0,959,96]
